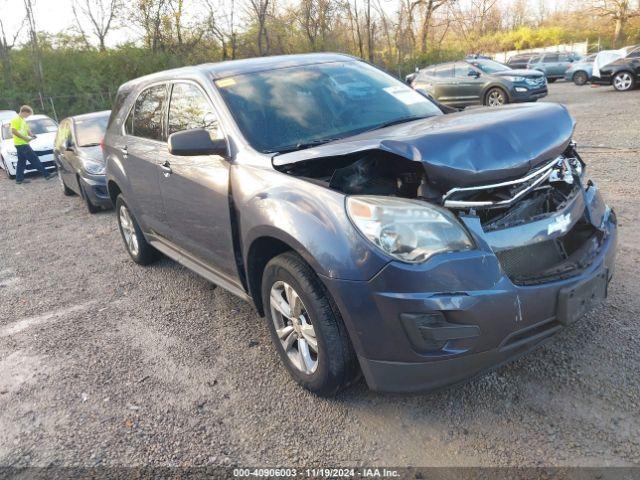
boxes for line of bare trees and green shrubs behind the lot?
[0,0,640,117]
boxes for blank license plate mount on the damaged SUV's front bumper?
[558,269,608,325]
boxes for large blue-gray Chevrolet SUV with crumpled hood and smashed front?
[105,54,616,395]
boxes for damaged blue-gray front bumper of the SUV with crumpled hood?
[323,183,617,391]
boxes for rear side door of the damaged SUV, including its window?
[117,83,167,235]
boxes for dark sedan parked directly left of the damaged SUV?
[53,110,112,213]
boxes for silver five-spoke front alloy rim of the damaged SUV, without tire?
[270,281,318,375]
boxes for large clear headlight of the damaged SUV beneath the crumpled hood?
[347,195,474,263]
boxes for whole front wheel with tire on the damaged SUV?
[262,252,358,396]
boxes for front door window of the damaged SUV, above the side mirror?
[167,83,221,138]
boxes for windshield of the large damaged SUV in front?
[216,62,442,153]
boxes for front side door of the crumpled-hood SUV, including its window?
[160,81,238,283]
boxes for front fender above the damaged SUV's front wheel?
[231,165,389,280]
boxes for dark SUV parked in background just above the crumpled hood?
[411,59,548,107]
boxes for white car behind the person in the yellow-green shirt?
[0,115,58,178]
